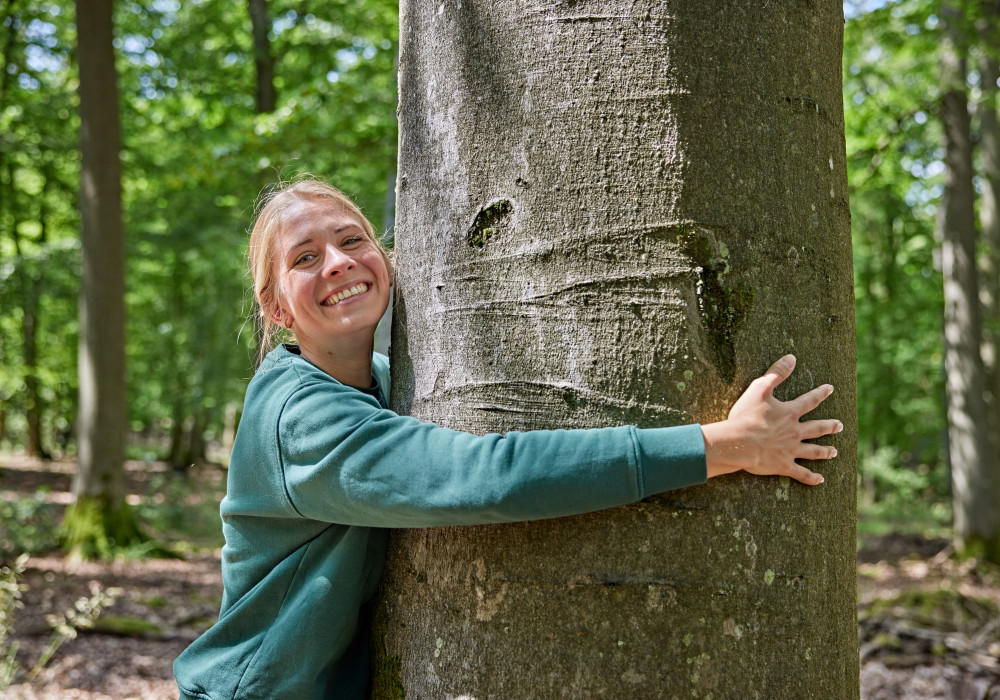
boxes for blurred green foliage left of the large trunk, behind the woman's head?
[0,0,398,466]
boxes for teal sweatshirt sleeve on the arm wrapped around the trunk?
[277,383,706,527]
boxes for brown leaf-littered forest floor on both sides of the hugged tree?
[0,456,1000,700]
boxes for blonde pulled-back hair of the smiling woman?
[247,178,392,362]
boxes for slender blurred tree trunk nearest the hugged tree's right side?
[939,9,1000,558]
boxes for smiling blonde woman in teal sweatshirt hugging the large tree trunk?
[174,180,843,700]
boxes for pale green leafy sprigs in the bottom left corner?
[0,554,122,695]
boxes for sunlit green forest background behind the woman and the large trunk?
[0,0,1000,698]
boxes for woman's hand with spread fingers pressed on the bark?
[701,355,844,486]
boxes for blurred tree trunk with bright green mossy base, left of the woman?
[63,0,138,555]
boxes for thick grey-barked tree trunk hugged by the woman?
[374,0,859,699]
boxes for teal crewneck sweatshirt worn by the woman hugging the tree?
[174,345,706,700]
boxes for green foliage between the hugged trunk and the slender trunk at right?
[844,0,947,492]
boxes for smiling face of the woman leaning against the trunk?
[272,199,390,357]
